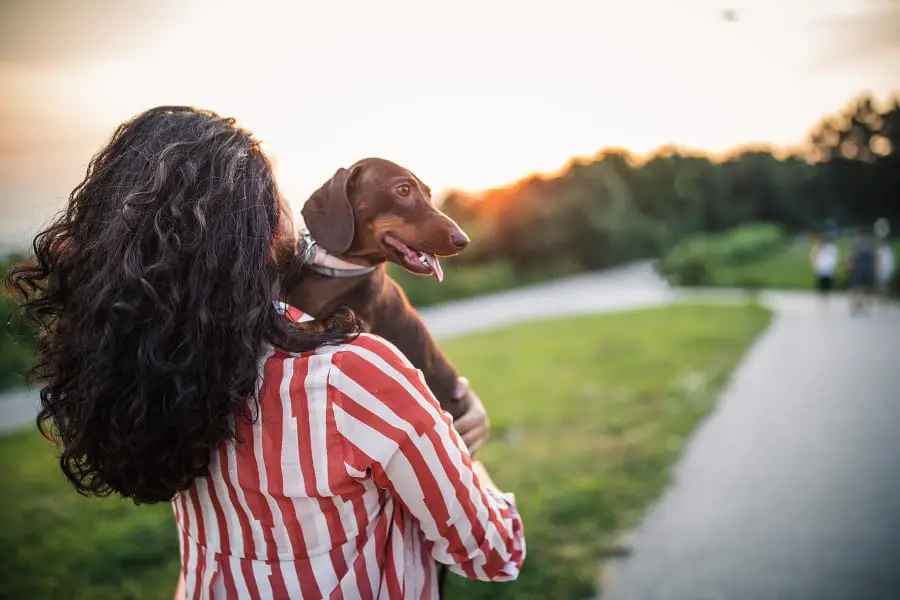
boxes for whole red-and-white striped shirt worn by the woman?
[173,307,525,600]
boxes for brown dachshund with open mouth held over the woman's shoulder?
[287,158,469,419]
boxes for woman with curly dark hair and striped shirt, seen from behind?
[10,107,525,599]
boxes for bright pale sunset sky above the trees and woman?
[0,0,900,246]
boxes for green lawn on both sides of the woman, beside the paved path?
[0,305,770,600]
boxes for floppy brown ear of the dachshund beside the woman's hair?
[300,168,356,254]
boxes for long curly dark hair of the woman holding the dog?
[7,106,359,503]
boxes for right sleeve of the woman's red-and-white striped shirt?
[329,335,525,581]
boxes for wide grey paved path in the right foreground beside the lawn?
[602,294,900,600]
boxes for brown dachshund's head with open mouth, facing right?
[302,158,469,280]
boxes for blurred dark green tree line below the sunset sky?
[443,95,900,273]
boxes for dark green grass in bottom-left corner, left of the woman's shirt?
[0,431,179,600]
